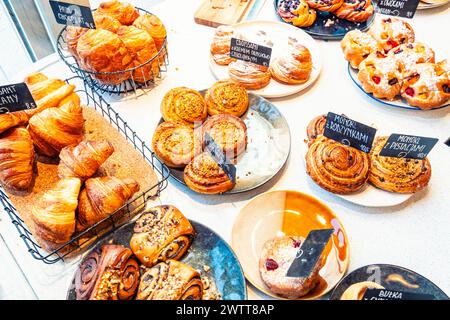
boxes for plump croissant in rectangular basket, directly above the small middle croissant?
[28,98,84,157]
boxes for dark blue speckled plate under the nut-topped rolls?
[67,220,247,300]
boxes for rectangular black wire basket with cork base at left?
[0,76,170,264]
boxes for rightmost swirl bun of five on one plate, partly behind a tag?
[202,114,247,159]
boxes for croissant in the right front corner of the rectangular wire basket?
[77,177,139,231]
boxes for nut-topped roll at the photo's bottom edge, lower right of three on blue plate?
[136,260,203,300]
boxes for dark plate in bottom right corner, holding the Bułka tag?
[330,264,449,300]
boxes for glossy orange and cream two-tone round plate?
[231,191,350,300]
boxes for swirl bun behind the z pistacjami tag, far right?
[369,137,431,193]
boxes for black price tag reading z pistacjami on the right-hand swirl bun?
[380,133,438,160]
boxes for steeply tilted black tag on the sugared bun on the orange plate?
[286,229,334,278]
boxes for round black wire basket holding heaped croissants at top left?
[56,8,169,95]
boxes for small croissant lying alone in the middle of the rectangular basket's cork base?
[58,140,114,181]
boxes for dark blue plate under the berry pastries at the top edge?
[273,0,376,40]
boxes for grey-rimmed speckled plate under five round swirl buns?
[160,90,291,194]
